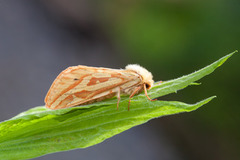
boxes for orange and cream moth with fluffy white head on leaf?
[45,64,154,110]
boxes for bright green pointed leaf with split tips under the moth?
[0,51,236,160]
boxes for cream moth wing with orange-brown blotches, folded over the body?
[45,65,140,109]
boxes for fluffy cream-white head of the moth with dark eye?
[125,64,154,89]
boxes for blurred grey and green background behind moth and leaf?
[0,0,240,160]
